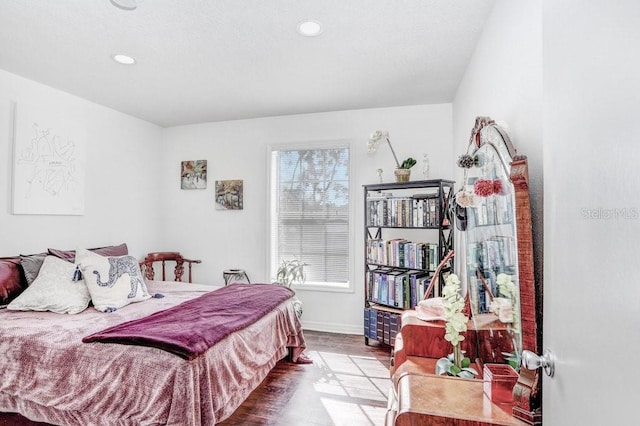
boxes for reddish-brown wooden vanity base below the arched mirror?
[386,310,525,426]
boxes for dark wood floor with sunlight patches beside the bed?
[0,331,391,426]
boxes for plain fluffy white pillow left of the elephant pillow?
[7,256,91,314]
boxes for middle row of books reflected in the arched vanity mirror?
[467,235,517,271]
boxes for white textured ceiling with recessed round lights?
[0,0,493,127]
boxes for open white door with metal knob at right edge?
[543,0,640,426]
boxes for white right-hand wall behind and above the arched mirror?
[453,0,543,294]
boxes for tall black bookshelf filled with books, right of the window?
[364,179,455,346]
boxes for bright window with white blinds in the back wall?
[270,144,351,289]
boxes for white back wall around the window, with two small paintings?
[160,104,453,333]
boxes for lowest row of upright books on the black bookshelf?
[365,267,438,309]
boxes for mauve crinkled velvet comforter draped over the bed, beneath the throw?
[0,281,305,426]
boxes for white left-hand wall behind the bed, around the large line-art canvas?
[0,71,162,256]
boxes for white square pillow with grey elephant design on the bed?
[76,249,151,312]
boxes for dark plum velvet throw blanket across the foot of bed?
[82,284,294,360]
